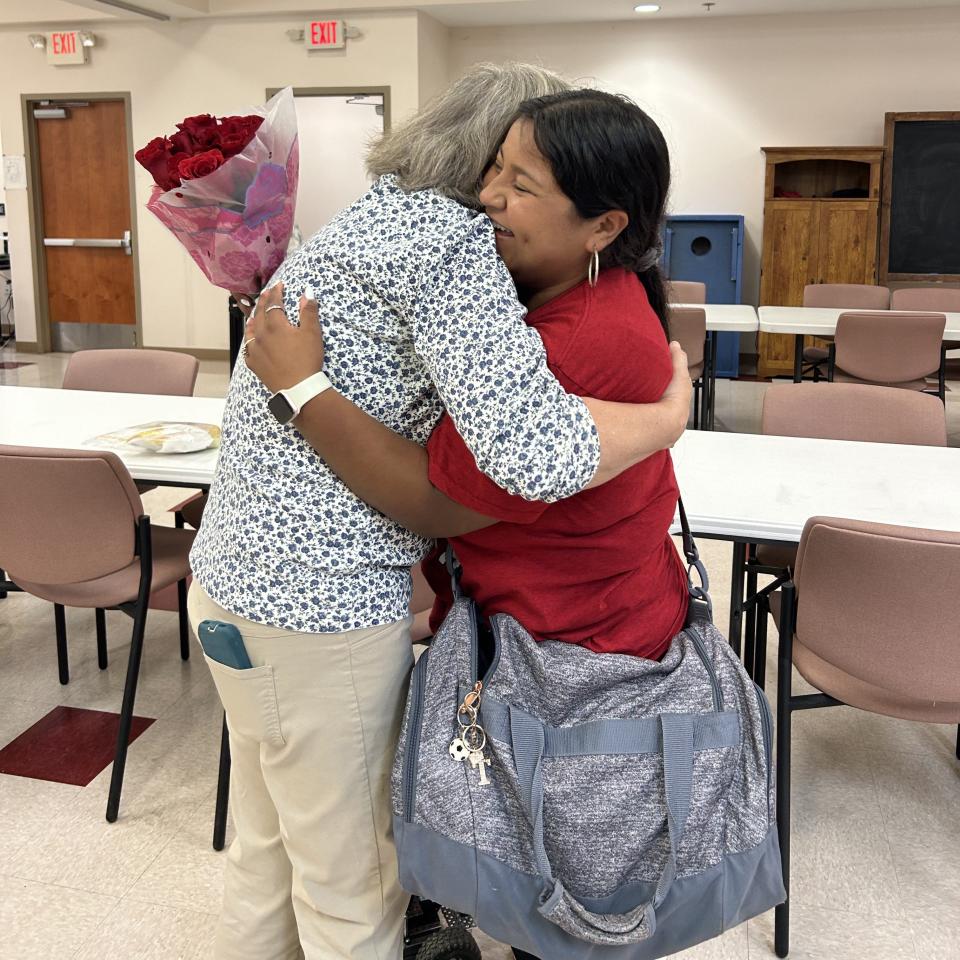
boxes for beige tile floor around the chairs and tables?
[0,349,960,960]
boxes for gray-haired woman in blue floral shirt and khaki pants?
[189,64,689,960]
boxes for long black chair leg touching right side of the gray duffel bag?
[773,583,796,957]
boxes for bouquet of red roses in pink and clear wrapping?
[136,87,300,293]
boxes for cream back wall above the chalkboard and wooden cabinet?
[450,3,960,303]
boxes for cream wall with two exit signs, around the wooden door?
[0,12,420,349]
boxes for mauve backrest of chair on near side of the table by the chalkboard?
[834,310,947,384]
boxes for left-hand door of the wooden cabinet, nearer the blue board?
[757,200,820,377]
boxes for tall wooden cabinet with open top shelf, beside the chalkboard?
[757,147,883,377]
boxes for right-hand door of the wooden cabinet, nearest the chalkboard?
[817,200,878,283]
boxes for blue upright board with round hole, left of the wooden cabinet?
[663,214,743,377]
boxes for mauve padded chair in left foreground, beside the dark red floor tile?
[0,446,194,822]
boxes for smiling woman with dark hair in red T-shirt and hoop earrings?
[248,90,687,658]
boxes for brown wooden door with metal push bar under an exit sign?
[32,100,137,345]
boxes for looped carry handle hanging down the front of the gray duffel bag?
[510,710,696,946]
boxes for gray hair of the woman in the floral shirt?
[367,63,570,207]
